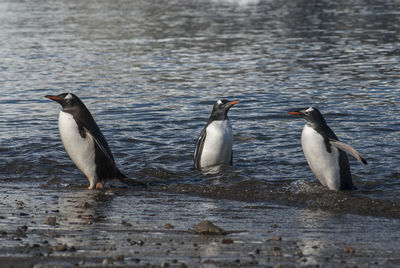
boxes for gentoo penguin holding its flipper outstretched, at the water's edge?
[289,107,367,191]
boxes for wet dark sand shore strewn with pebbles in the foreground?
[0,183,400,267]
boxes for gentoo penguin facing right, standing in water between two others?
[194,100,239,169]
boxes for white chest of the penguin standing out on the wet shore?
[58,111,97,179]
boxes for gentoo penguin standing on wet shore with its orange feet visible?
[45,93,142,190]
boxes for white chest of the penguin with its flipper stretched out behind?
[301,125,340,190]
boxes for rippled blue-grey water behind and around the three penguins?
[0,0,400,217]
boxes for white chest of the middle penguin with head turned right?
[200,120,233,167]
